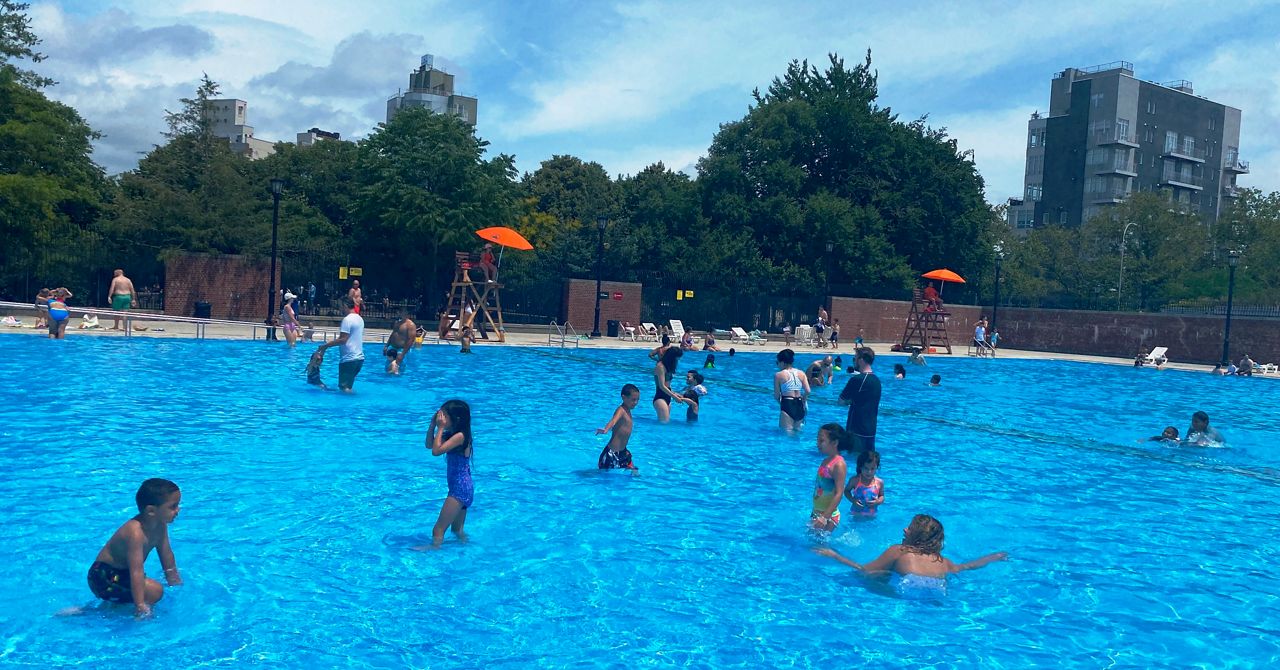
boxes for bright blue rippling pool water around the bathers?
[0,336,1280,669]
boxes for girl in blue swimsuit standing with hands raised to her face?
[413,400,472,550]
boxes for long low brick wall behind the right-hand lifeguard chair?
[831,297,1280,364]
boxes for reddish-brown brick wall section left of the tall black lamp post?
[164,254,282,322]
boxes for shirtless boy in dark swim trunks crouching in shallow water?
[88,479,182,616]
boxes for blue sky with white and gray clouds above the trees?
[29,0,1280,204]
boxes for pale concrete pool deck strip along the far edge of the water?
[0,314,1280,379]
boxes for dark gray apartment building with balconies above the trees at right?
[1009,60,1249,229]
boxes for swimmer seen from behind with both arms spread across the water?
[814,514,1009,596]
